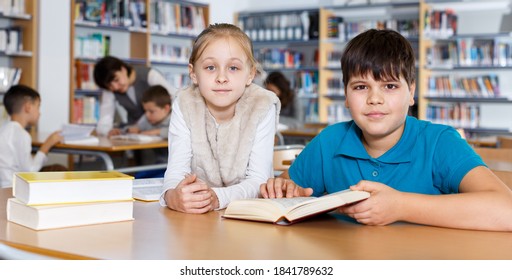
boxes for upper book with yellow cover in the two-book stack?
[13,171,133,205]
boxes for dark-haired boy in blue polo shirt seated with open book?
[260,30,512,231]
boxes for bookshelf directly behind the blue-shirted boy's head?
[319,1,419,124]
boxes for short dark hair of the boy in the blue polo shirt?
[341,29,416,90]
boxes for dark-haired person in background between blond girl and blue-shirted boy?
[264,72,302,129]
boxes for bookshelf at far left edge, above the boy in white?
[0,1,38,123]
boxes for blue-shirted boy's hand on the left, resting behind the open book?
[260,177,313,198]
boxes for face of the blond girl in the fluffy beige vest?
[189,38,256,122]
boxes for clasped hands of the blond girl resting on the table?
[165,174,219,214]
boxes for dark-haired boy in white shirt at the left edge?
[0,85,63,187]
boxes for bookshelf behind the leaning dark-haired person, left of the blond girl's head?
[69,0,209,124]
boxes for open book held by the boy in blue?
[223,190,370,225]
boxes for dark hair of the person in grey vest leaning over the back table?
[93,56,133,90]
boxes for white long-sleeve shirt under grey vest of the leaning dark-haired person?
[96,69,176,135]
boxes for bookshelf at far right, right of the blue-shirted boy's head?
[418,0,512,136]
